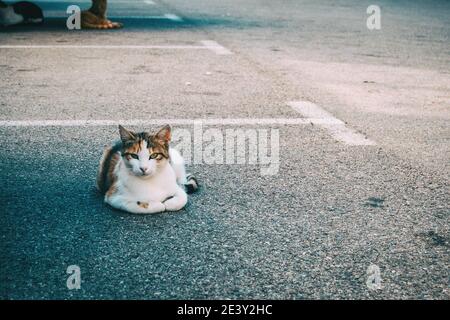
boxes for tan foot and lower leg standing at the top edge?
[81,0,122,29]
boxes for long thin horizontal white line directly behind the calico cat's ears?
[0,118,342,127]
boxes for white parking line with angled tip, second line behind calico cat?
[0,40,233,55]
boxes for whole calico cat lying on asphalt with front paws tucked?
[97,125,198,214]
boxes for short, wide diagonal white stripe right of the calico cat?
[288,101,376,146]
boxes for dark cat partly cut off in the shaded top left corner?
[0,1,44,27]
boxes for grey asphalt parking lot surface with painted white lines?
[0,0,450,299]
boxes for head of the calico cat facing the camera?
[119,125,171,178]
